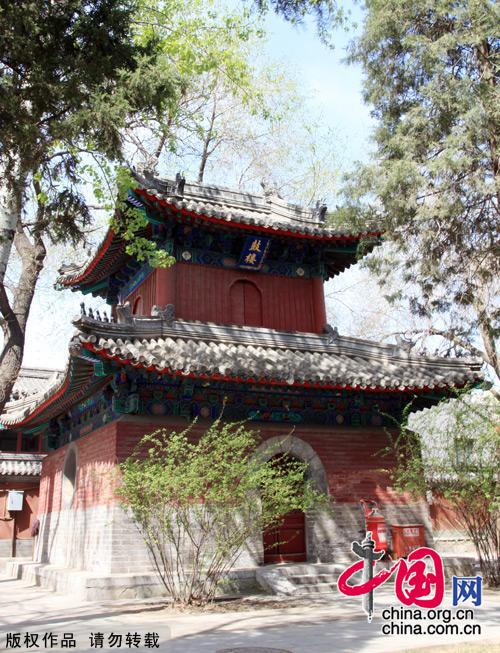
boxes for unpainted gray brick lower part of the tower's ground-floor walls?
[35,496,434,573]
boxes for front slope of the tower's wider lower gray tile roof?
[73,316,482,390]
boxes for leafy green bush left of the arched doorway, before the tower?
[117,419,329,605]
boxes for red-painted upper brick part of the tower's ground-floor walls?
[40,417,410,512]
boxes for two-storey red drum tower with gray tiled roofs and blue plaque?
[2,175,481,594]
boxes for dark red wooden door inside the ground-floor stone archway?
[263,510,307,564]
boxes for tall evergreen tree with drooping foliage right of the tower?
[344,0,500,374]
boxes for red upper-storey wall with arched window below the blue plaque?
[127,263,326,333]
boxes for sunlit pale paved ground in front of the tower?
[0,578,500,653]
